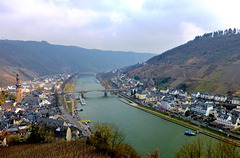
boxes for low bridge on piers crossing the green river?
[63,89,125,98]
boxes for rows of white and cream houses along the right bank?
[112,75,240,129]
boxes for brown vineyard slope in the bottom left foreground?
[0,140,108,158]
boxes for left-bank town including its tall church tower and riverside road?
[0,74,89,146]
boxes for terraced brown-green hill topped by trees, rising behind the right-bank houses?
[127,29,240,93]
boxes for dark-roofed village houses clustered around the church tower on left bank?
[0,75,85,145]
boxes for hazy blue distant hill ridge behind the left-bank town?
[0,40,153,85]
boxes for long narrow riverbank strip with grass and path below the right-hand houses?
[117,93,240,147]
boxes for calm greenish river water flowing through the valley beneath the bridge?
[75,74,207,158]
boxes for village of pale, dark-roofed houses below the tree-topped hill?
[109,70,240,137]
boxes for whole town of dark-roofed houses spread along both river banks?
[0,70,240,146]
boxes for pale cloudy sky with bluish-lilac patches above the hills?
[0,0,240,54]
